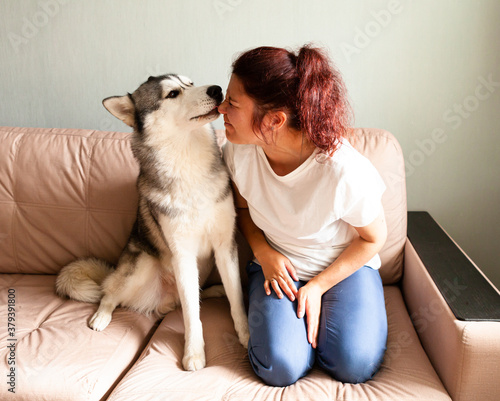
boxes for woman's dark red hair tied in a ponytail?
[232,45,352,154]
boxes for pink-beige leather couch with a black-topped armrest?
[0,127,500,401]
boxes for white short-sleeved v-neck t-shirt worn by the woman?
[223,139,385,281]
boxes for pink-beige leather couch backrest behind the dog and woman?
[0,127,406,284]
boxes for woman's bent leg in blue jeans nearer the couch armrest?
[317,268,388,383]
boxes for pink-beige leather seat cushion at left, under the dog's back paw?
[0,274,156,401]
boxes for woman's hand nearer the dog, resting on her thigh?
[256,247,299,301]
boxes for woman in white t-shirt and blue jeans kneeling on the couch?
[219,46,387,386]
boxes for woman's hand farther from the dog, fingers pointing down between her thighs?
[297,281,323,348]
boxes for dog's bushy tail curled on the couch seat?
[56,258,113,303]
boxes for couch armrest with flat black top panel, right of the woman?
[402,212,500,401]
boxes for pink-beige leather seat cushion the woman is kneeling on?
[105,286,450,401]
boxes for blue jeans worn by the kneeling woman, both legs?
[247,262,387,387]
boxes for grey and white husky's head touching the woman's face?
[102,74,223,131]
